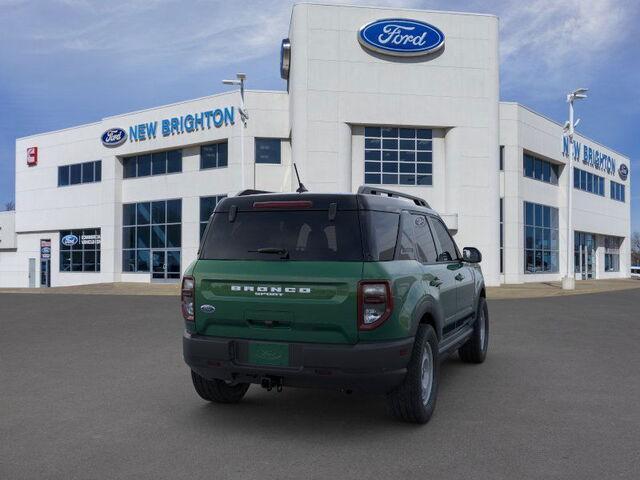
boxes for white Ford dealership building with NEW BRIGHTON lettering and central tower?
[0,4,631,287]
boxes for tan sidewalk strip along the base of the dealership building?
[0,279,640,300]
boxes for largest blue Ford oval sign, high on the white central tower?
[358,18,444,57]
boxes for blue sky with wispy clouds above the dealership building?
[0,0,640,230]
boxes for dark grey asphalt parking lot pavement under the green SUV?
[0,290,640,480]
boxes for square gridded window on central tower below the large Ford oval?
[364,127,433,185]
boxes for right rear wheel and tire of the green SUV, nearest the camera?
[387,325,440,423]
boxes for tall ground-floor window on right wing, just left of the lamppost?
[524,202,559,273]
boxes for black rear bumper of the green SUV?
[182,332,413,392]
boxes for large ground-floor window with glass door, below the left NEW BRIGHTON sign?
[122,199,182,278]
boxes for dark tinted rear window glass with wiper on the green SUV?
[200,210,363,261]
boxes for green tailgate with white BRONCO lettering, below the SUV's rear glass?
[193,260,363,344]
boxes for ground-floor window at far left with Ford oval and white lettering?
[60,228,101,272]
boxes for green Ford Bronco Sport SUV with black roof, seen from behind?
[182,187,489,423]
